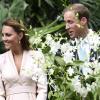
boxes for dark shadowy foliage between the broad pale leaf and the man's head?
[25,0,68,27]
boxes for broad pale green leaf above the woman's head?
[0,0,27,27]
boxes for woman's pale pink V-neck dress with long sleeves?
[0,51,47,100]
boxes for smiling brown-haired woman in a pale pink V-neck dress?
[0,19,47,100]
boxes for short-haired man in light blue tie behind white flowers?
[63,4,100,61]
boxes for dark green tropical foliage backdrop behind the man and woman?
[0,0,100,51]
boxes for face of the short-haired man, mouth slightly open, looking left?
[64,11,81,39]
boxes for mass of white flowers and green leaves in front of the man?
[29,30,100,100]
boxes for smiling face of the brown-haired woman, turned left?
[2,25,20,49]
